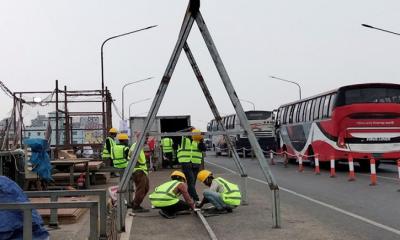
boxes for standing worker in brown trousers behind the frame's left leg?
[128,140,150,213]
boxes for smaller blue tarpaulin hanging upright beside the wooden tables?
[25,138,53,182]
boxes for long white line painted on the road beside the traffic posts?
[205,161,400,236]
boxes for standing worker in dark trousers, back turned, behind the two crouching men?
[178,129,203,201]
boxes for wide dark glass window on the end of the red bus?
[337,86,400,106]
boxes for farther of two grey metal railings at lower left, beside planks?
[24,189,107,239]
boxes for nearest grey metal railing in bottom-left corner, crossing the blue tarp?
[0,201,101,240]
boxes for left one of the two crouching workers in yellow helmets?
[149,171,195,219]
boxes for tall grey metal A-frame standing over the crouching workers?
[117,0,281,231]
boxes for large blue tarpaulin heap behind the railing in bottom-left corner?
[0,176,49,240]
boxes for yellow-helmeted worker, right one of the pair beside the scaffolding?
[111,133,129,169]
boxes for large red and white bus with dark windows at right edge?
[276,83,400,170]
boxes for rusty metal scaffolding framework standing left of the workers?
[10,80,112,156]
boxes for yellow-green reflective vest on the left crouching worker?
[149,180,180,207]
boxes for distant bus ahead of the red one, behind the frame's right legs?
[207,110,276,155]
